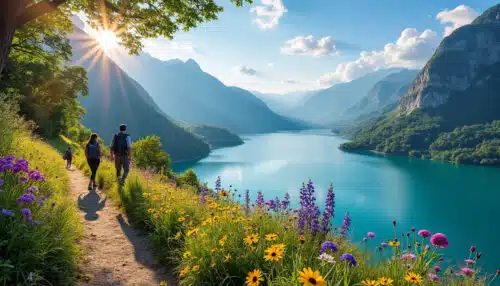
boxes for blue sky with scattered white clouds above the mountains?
[139,0,496,93]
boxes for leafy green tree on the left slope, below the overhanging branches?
[0,11,88,137]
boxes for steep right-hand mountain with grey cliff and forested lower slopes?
[342,4,500,165]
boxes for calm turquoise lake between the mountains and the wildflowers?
[174,131,500,271]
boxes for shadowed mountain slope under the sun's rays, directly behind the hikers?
[70,27,210,161]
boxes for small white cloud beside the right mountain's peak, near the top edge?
[436,5,479,37]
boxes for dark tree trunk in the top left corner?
[0,0,24,80]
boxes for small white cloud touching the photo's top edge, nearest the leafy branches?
[250,0,287,30]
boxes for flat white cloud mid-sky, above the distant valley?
[281,35,338,57]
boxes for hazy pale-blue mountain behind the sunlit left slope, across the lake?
[110,53,304,134]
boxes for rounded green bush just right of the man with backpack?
[132,136,170,174]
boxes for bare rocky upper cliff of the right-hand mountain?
[399,4,500,115]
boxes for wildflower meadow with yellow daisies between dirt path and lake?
[66,135,495,286]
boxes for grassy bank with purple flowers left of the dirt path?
[0,100,81,285]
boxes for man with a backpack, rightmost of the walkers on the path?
[111,124,132,185]
